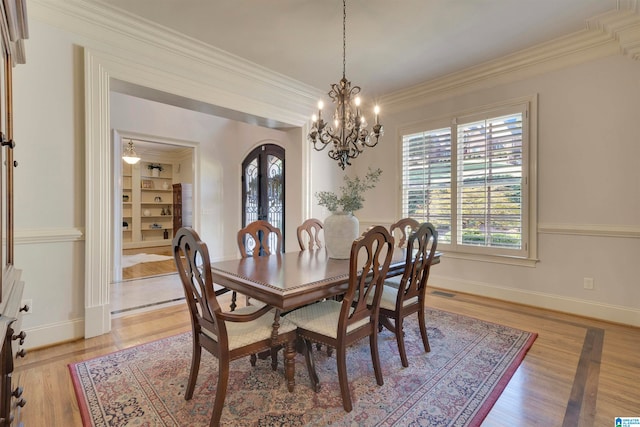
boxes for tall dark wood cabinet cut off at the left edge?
[0,0,29,427]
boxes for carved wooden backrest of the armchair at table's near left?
[173,227,227,346]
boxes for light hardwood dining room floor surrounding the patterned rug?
[15,289,640,427]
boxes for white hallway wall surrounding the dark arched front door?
[110,92,302,260]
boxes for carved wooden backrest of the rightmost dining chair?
[396,222,438,308]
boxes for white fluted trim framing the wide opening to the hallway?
[84,49,310,338]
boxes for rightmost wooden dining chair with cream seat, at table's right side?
[376,222,438,368]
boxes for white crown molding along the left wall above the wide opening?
[29,0,321,125]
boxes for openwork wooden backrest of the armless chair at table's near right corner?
[338,225,393,337]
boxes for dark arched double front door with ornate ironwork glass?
[242,144,285,248]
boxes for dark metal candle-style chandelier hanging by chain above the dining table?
[308,0,383,169]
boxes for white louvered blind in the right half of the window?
[457,113,523,250]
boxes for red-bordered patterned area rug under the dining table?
[69,309,537,427]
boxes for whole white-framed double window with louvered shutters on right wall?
[402,102,535,258]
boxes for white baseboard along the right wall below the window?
[429,272,640,327]
